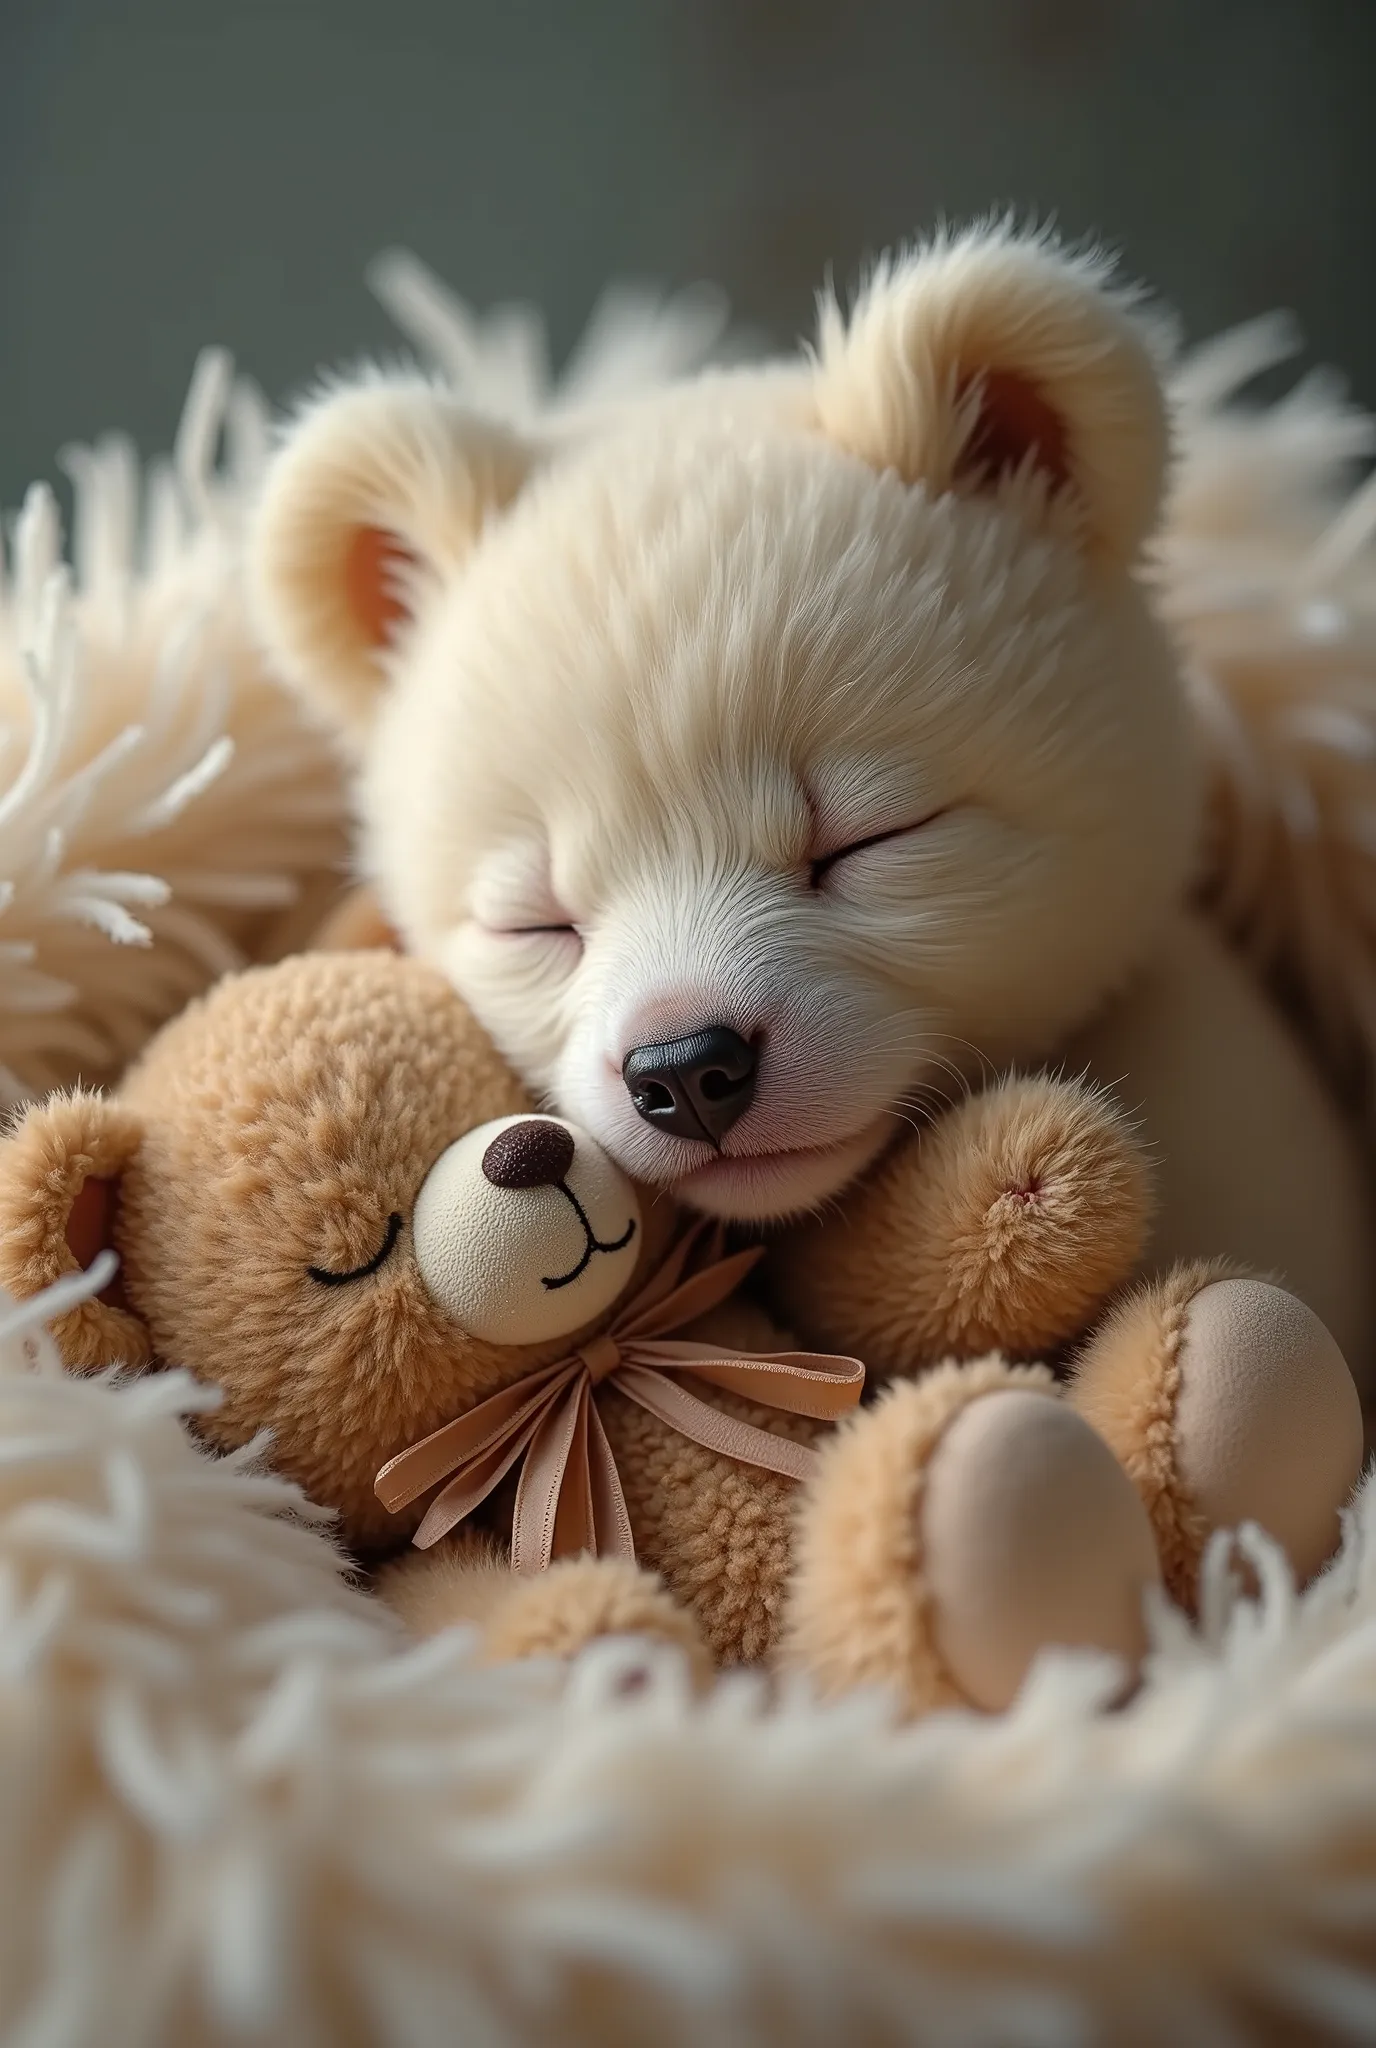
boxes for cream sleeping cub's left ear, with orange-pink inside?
[248,377,534,737]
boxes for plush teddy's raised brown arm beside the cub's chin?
[768,1075,1151,1376]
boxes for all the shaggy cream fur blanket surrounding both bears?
[0,256,1376,2048]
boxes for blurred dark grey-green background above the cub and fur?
[0,0,1376,504]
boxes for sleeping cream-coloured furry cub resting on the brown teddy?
[248,221,1376,1409]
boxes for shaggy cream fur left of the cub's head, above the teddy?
[0,352,346,1100]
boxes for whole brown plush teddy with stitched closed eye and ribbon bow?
[0,950,1360,1712]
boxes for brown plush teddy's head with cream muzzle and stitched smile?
[0,952,672,1550]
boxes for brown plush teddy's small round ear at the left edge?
[0,1092,152,1372]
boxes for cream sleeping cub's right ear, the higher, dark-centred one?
[815,229,1169,563]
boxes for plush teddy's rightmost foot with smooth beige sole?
[1071,1264,1362,1606]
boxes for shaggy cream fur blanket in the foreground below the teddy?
[0,1277,1376,2048]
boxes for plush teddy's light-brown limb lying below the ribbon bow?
[377,1536,711,1681]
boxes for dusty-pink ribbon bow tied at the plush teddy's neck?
[375,1223,864,1571]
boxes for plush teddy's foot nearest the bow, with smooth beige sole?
[782,1358,1159,1714]
